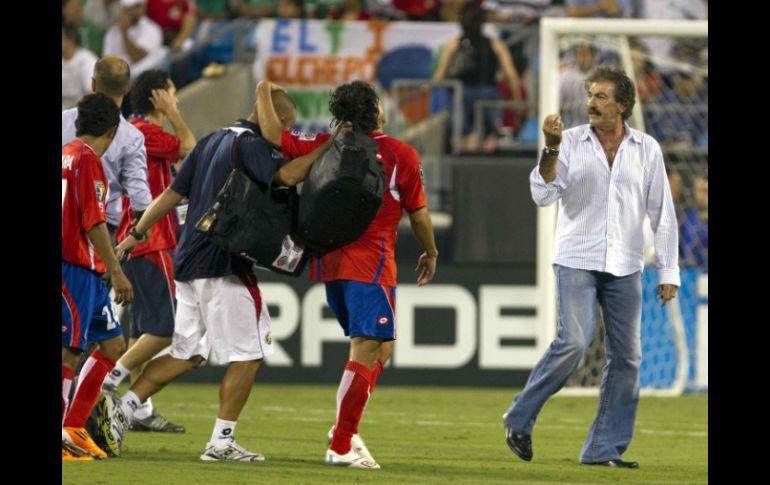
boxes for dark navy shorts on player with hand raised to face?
[123,249,176,338]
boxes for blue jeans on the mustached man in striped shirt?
[504,264,642,463]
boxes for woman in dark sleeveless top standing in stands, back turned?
[433,3,521,152]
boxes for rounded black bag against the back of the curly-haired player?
[293,131,385,255]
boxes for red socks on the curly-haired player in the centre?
[331,360,374,455]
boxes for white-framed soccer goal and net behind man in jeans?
[537,18,708,395]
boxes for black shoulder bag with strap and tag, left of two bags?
[195,130,307,276]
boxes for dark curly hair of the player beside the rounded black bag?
[329,81,379,133]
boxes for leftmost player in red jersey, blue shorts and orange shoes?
[61,94,133,459]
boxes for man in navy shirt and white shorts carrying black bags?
[109,85,328,462]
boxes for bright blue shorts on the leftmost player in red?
[61,261,123,350]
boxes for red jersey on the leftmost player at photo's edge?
[61,138,108,274]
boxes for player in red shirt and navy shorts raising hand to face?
[102,69,195,433]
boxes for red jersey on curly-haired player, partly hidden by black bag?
[281,131,428,286]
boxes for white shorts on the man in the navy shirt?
[171,275,273,363]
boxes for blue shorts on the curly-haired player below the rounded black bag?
[326,280,396,340]
